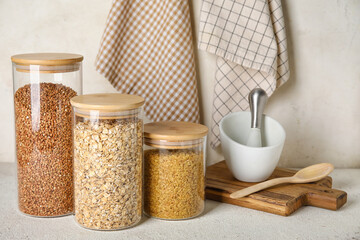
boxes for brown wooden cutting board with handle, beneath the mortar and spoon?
[206,161,347,216]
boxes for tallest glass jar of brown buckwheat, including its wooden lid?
[11,53,83,217]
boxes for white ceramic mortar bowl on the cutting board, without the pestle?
[220,112,286,182]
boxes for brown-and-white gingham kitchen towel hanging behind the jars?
[96,0,199,122]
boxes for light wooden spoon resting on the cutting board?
[230,163,334,198]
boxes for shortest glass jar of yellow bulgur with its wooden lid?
[144,121,208,220]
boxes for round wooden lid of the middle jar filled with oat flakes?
[70,93,145,112]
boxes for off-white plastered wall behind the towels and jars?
[0,0,360,167]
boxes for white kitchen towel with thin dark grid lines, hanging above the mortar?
[199,0,290,148]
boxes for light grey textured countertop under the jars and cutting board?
[0,163,360,240]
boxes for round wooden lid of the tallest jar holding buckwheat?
[11,53,84,66]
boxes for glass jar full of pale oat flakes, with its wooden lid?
[71,93,144,230]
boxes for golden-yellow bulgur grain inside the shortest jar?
[144,148,205,219]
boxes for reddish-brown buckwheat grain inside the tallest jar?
[14,83,76,217]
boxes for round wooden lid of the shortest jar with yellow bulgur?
[144,121,208,141]
